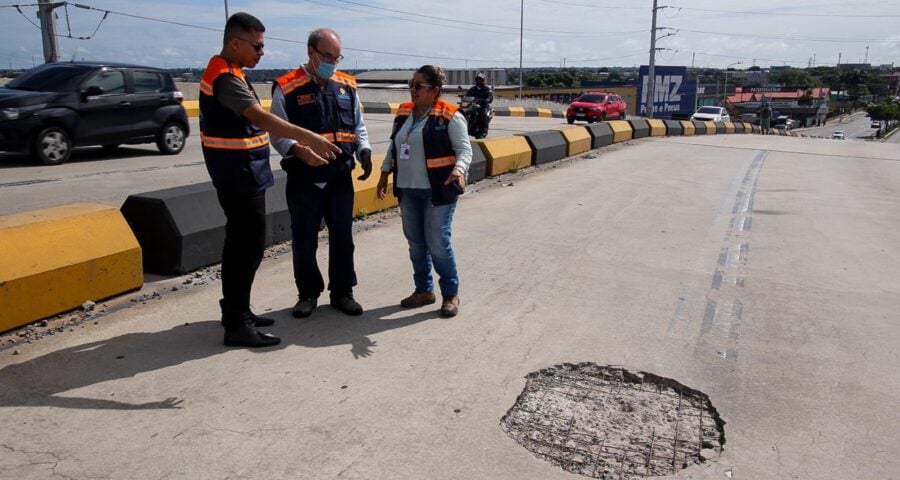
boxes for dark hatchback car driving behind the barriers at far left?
[0,62,190,165]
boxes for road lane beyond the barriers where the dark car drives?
[0,114,565,215]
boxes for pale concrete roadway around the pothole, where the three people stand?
[0,135,900,480]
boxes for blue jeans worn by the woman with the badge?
[400,188,459,297]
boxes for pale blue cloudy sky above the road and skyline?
[0,0,900,69]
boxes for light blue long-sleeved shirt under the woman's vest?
[381,112,472,188]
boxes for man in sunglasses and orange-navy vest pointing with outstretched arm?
[200,12,340,347]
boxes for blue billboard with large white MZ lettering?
[638,65,697,118]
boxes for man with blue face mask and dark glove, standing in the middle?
[272,28,372,318]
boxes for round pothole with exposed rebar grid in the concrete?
[500,363,725,480]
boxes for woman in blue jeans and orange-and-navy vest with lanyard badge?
[376,65,472,317]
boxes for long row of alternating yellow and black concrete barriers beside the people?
[10,114,802,330]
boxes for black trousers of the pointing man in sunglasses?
[216,190,266,317]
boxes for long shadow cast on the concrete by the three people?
[0,305,439,410]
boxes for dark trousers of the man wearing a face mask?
[285,169,356,298]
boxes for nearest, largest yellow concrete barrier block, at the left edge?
[0,203,144,331]
